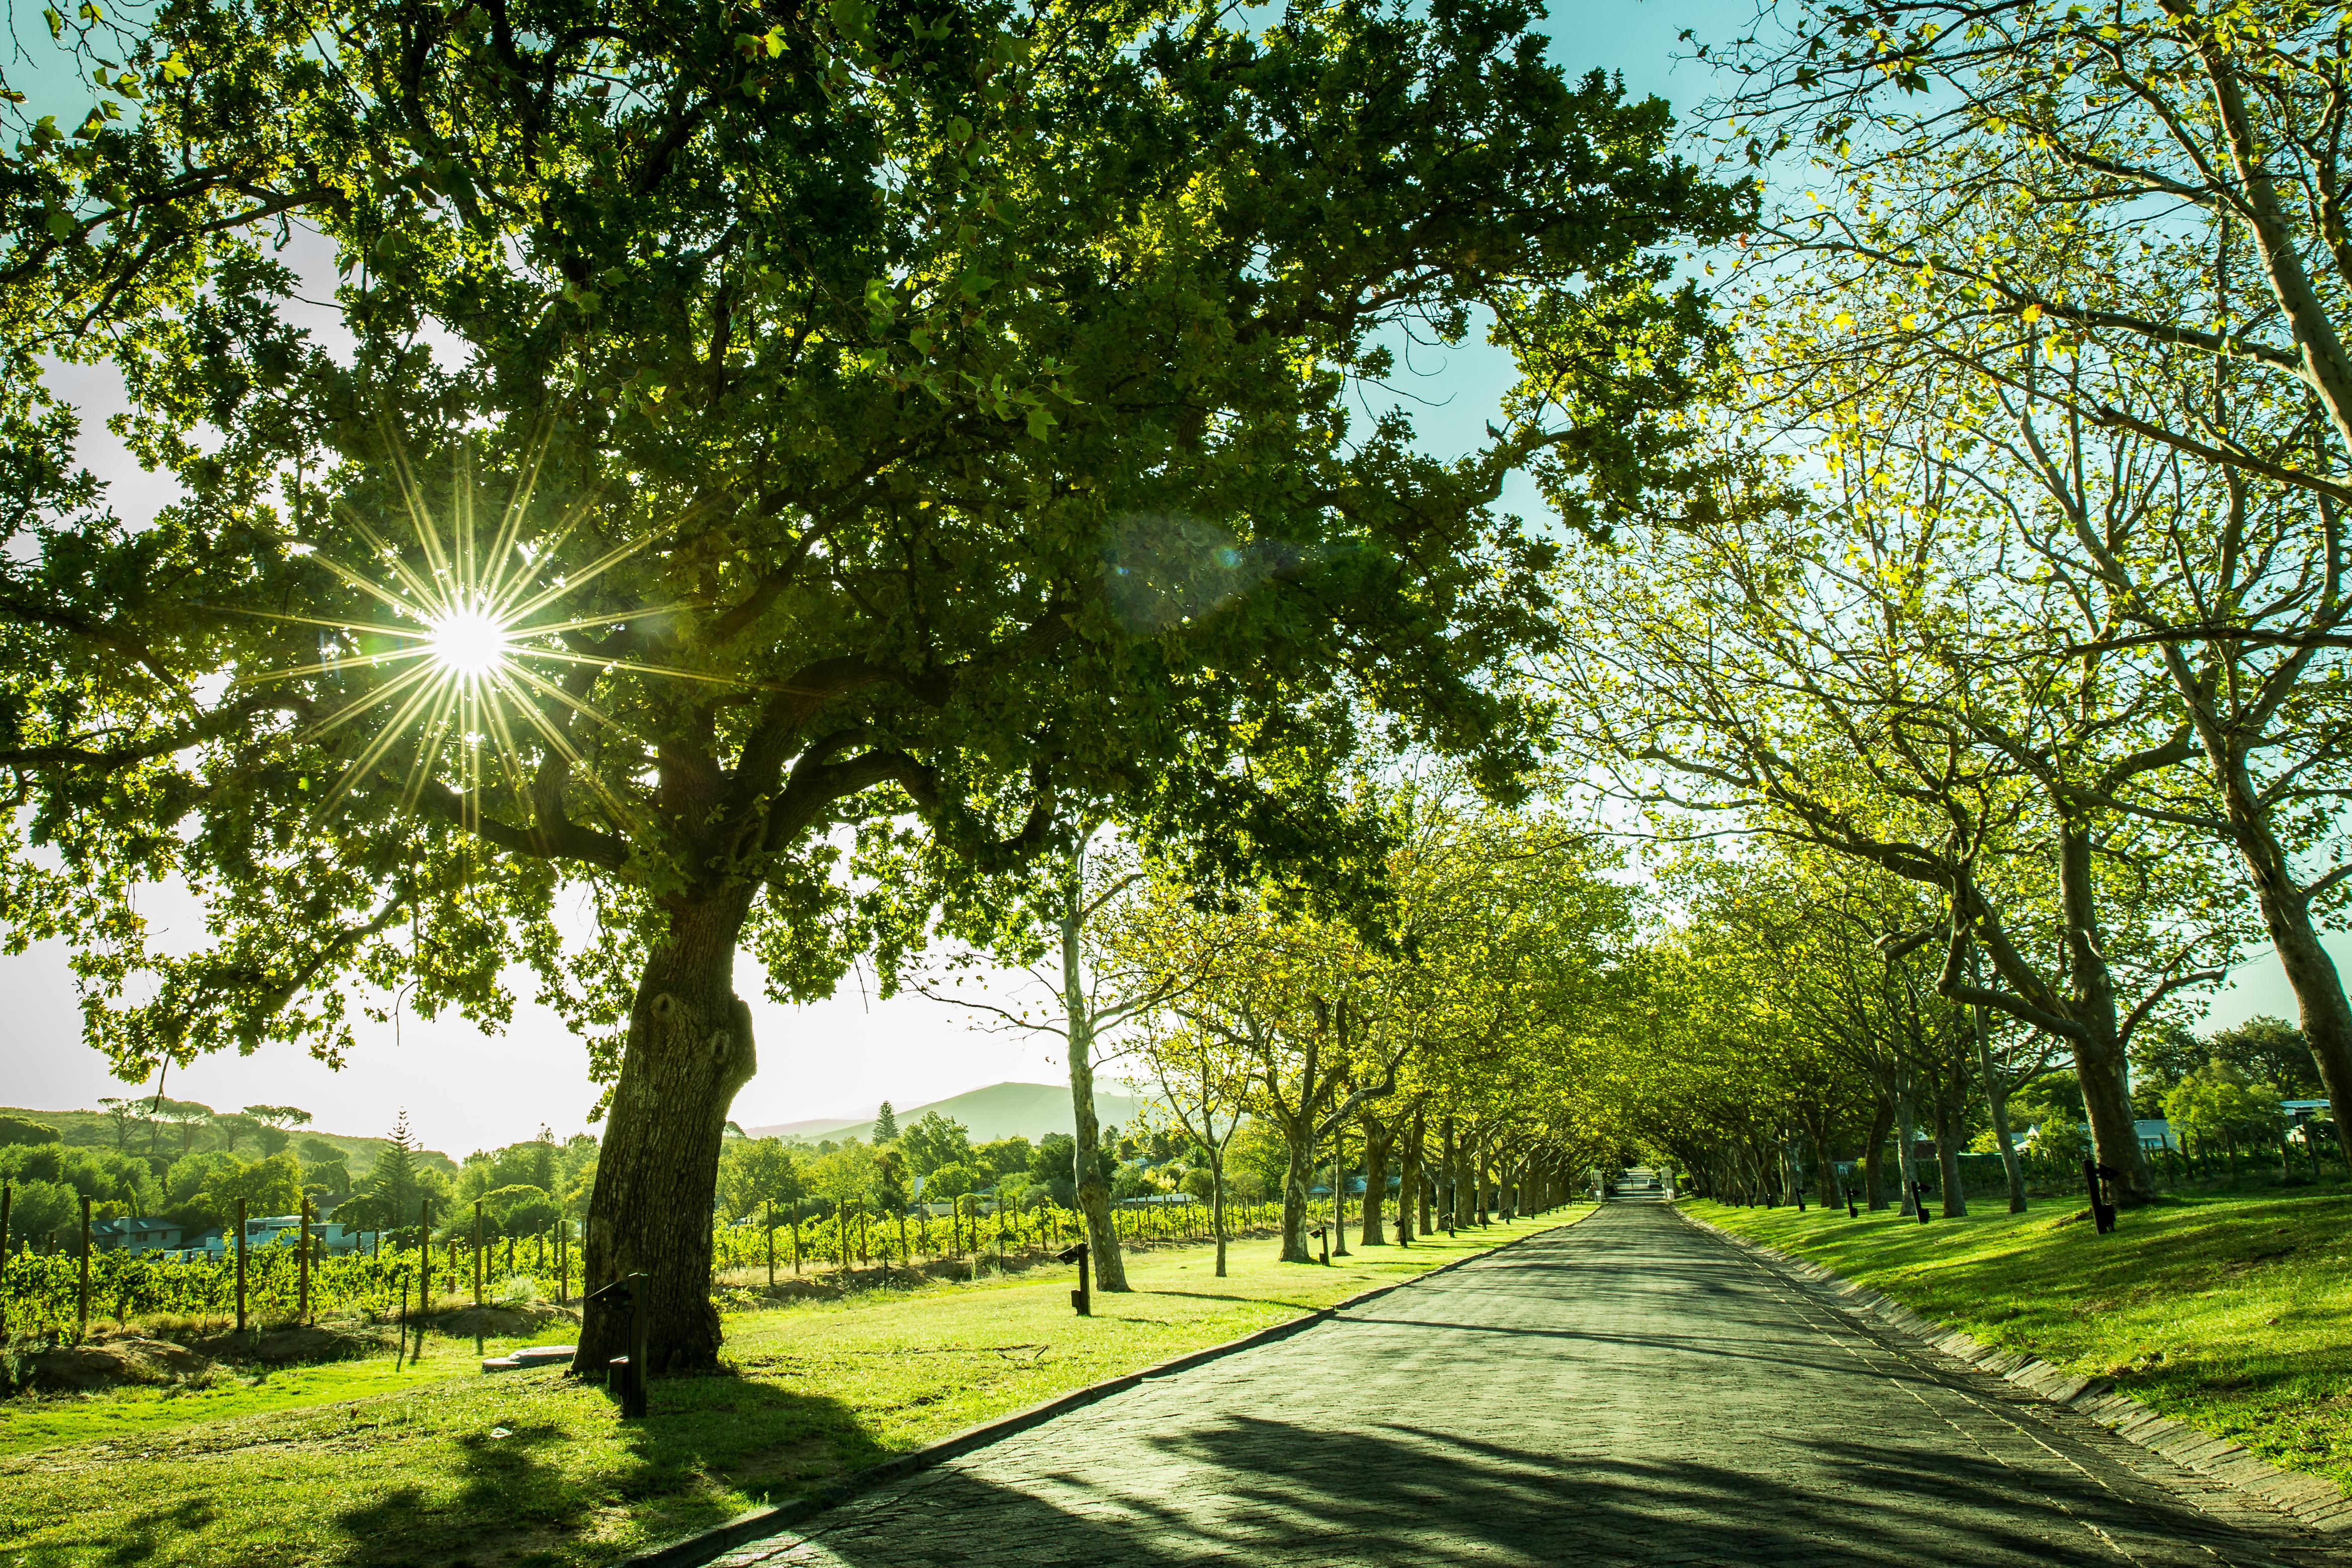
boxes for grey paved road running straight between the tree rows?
[722,1201,2352,1568]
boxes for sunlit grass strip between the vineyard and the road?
[0,1211,1583,1568]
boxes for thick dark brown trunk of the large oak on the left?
[572,889,757,1378]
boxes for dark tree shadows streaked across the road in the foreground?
[790,1418,2286,1568]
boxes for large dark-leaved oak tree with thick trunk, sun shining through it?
[0,0,1743,1371]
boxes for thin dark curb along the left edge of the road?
[611,1206,1599,1568]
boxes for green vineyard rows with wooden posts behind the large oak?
[0,1204,1282,1336]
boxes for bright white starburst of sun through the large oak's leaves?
[240,430,734,825]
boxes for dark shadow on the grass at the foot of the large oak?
[334,1373,889,1568]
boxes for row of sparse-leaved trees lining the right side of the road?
[1529,0,2352,1201]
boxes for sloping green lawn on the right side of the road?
[1689,1187,2352,1488]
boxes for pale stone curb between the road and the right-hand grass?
[1675,1204,2352,1535]
